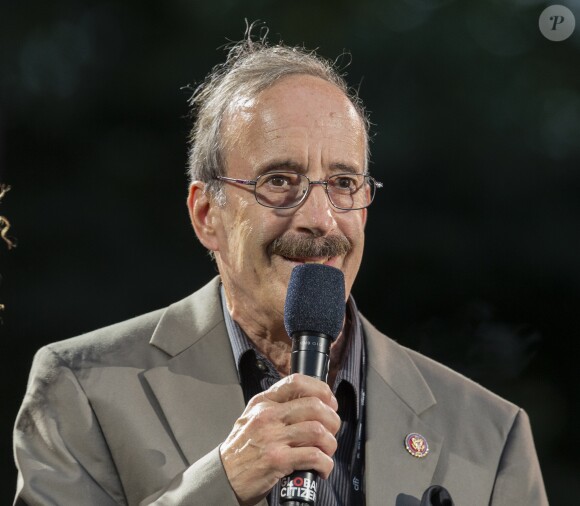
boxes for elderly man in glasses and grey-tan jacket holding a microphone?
[15,33,547,506]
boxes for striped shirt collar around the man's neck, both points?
[220,285,364,418]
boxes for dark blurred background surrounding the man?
[0,0,580,505]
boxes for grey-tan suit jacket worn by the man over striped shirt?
[14,278,547,506]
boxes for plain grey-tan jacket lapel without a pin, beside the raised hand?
[144,279,245,464]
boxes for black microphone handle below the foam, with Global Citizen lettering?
[280,331,332,506]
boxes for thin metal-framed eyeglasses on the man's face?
[215,172,383,211]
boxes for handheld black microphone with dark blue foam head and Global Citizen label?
[280,264,345,506]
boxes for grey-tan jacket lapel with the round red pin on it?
[363,320,443,506]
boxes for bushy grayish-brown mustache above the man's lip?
[270,235,352,258]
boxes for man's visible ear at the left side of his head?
[187,181,219,251]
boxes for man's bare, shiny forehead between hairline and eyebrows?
[222,75,366,170]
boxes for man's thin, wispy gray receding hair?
[188,24,370,202]
